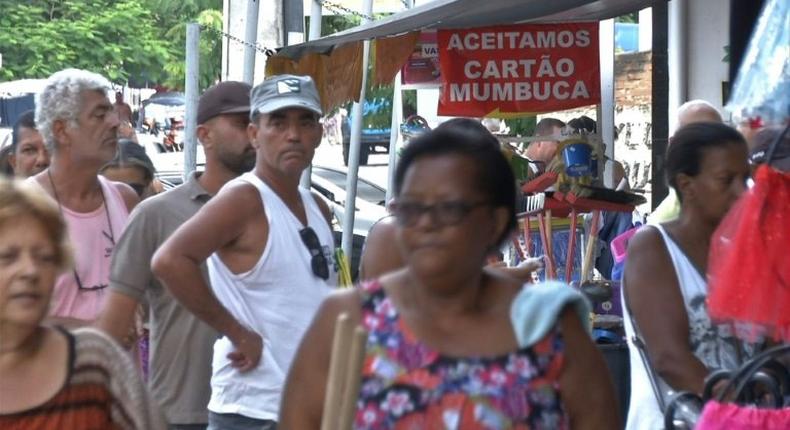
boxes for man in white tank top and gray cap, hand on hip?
[152,75,337,430]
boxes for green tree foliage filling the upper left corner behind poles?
[0,0,222,89]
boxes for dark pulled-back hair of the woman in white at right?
[666,122,746,194]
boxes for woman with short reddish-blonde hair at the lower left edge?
[0,180,165,430]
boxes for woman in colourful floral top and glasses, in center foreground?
[280,119,619,429]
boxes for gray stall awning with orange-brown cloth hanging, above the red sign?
[266,0,664,112]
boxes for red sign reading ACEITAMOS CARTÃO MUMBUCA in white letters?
[438,22,601,117]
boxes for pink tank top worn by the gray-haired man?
[35,176,129,321]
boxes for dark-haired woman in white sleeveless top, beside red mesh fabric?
[623,123,752,429]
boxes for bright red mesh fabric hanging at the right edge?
[708,165,790,341]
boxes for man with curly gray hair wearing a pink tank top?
[27,69,139,328]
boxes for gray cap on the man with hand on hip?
[250,75,324,115]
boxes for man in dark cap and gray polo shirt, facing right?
[99,81,255,429]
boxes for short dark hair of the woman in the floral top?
[395,118,516,244]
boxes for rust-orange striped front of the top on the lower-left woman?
[0,383,120,430]
